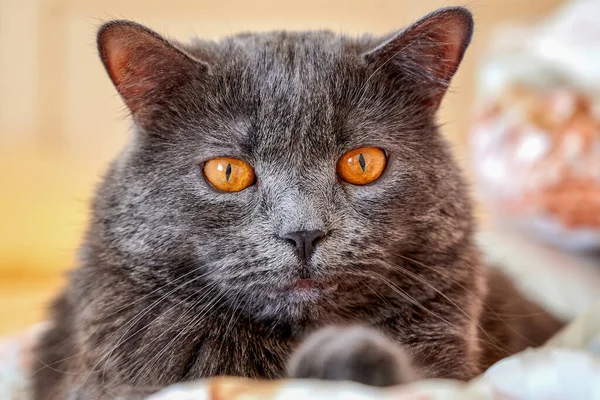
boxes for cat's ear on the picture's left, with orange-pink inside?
[98,21,208,119]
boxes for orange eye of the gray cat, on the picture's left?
[204,157,254,192]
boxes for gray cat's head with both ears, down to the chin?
[88,8,472,321]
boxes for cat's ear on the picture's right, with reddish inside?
[363,7,473,109]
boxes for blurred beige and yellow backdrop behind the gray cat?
[0,0,600,336]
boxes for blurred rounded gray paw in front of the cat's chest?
[288,326,416,386]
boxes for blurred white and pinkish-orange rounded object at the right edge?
[471,0,600,250]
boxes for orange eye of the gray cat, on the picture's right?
[337,147,387,185]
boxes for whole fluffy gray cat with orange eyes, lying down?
[34,8,560,400]
